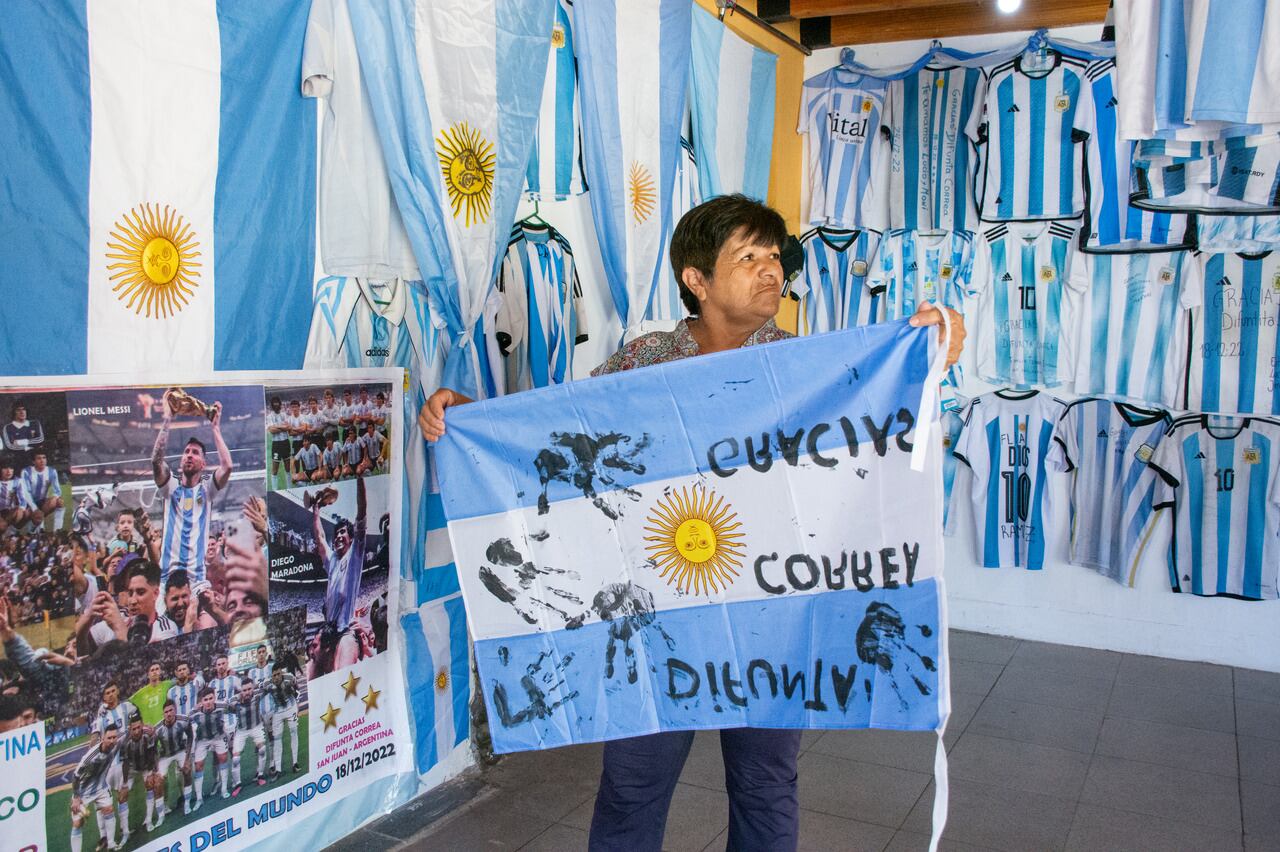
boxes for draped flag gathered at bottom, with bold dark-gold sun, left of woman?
[349,0,556,397]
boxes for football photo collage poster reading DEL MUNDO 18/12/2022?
[0,370,416,852]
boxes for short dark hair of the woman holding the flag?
[671,194,787,316]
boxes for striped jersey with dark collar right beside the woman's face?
[791,228,884,334]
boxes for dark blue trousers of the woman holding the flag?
[590,728,800,852]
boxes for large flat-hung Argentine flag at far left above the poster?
[0,0,315,375]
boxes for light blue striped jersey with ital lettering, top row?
[796,65,892,232]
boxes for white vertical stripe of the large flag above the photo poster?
[87,0,221,372]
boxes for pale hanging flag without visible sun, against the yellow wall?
[690,6,778,201]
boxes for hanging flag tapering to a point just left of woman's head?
[573,0,692,338]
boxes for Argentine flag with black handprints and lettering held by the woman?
[436,321,946,752]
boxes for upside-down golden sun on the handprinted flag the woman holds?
[644,485,744,594]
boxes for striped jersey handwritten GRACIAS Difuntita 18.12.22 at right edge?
[1176,252,1280,414]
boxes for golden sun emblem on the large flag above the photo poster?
[106,203,201,319]
